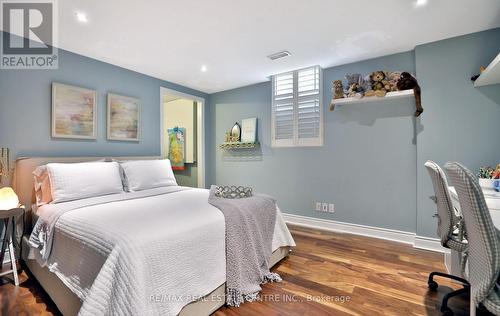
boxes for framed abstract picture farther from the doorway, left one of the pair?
[51,82,97,140]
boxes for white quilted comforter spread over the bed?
[30,187,295,315]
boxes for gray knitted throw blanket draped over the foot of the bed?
[208,185,281,307]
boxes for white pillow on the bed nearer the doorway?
[121,159,177,191]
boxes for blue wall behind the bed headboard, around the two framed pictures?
[0,31,208,163]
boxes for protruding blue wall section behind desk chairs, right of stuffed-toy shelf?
[415,29,500,236]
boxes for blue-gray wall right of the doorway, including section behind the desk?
[208,29,500,237]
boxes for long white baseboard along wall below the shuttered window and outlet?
[283,213,447,252]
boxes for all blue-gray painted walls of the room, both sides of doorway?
[0,29,500,237]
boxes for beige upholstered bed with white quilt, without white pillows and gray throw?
[13,157,295,315]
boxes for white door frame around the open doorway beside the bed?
[160,87,206,188]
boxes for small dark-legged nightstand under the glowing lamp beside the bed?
[0,208,24,286]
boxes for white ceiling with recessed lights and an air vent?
[13,0,500,93]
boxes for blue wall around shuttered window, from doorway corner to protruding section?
[209,52,416,231]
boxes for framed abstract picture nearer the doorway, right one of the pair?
[106,93,141,142]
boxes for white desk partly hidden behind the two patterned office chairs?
[444,186,500,276]
